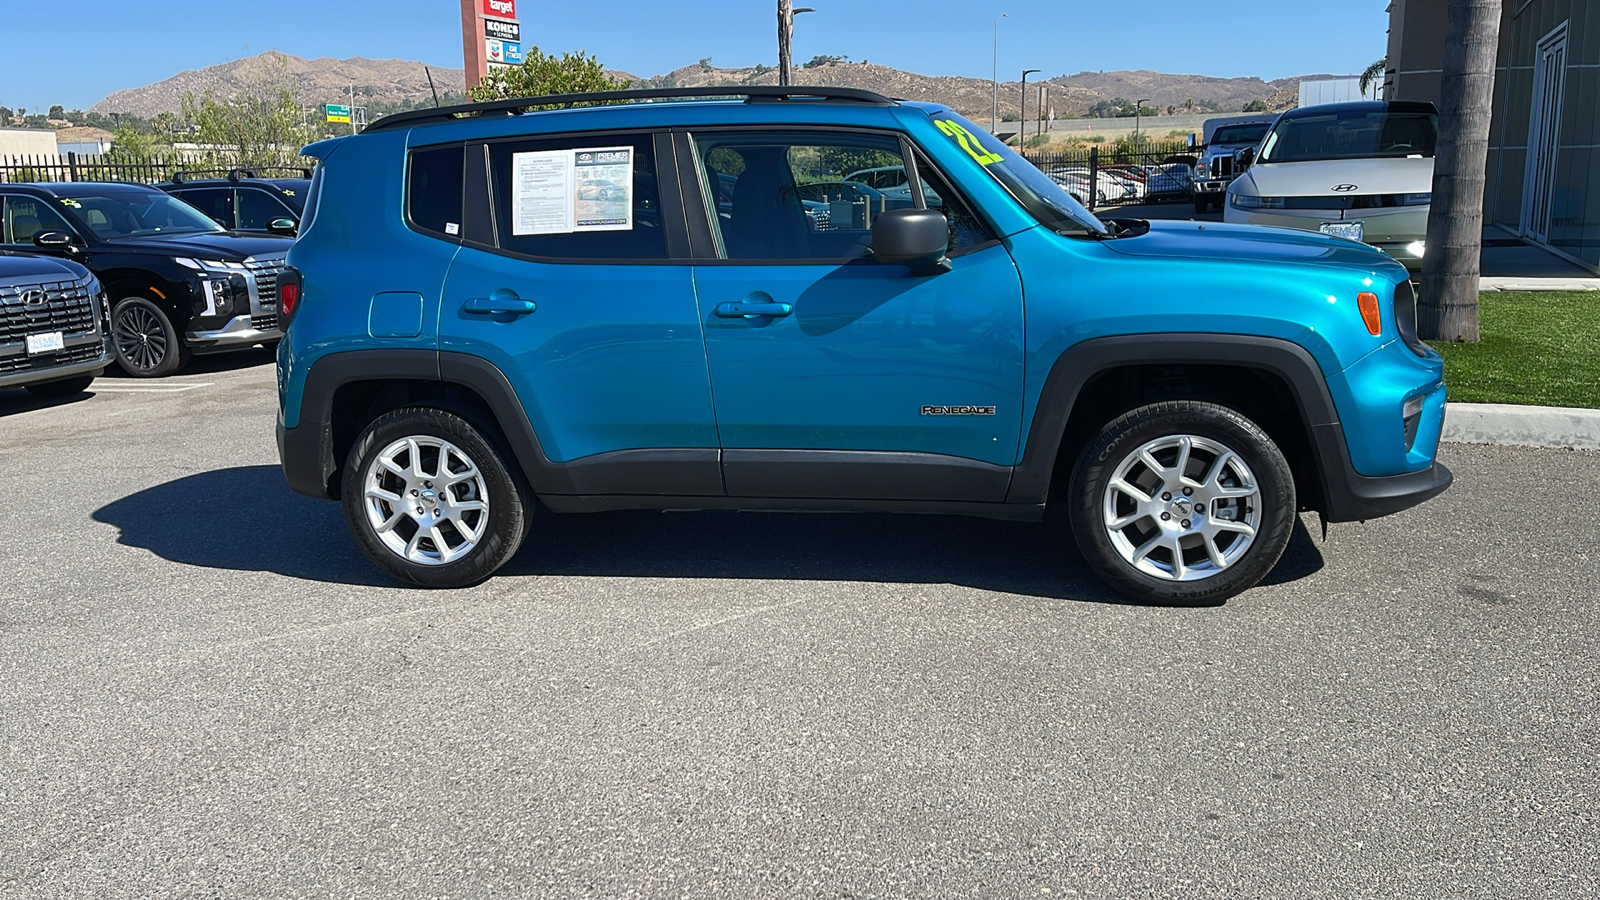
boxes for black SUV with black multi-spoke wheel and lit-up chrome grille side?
[0,183,293,378]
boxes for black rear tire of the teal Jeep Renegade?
[341,407,533,588]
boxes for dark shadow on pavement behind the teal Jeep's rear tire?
[94,466,398,586]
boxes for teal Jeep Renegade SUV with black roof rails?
[278,88,1450,602]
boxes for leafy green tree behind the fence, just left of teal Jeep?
[182,56,320,168]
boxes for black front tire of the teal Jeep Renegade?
[1069,400,1298,604]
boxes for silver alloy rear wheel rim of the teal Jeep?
[362,436,490,565]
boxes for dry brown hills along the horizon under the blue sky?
[91,51,1301,122]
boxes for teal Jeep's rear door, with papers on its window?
[435,133,722,495]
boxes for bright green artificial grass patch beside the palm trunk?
[1429,291,1600,408]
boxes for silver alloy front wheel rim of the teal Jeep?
[1101,434,1261,581]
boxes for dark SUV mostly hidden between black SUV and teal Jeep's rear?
[157,167,310,234]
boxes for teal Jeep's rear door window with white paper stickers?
[490,135,667,259]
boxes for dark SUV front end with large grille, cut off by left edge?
[0,251,110,397]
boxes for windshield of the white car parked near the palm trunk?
[1261,109,1438,162]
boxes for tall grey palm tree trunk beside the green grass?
[1418,0,1501,341]
